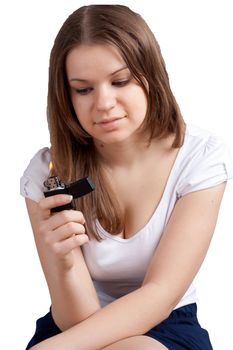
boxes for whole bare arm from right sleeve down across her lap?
[29,184,225,350]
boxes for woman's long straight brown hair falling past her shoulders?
[48,5,183,239]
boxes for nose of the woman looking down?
[95,86,116,112]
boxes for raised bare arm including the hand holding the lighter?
[26,196,100,330]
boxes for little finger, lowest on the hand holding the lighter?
[54,234,89,257]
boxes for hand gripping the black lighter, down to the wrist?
[38,194,88,271]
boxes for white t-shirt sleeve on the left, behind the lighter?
[20,147,50,202]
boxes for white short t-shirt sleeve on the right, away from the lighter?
[177,135,233,198]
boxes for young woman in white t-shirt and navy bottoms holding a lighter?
[21,5,233,350]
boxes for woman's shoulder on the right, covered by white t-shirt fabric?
[178,124,233,197]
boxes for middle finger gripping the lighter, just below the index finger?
[47,210,85,231]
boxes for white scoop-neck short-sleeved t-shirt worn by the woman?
[21,124,233,308]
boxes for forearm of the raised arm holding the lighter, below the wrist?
[43,247,100,331]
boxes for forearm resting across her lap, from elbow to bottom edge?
[33,284,172,350]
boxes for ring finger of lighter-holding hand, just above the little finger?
[49,222,85,243]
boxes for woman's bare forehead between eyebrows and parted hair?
[66,44,126,78]
